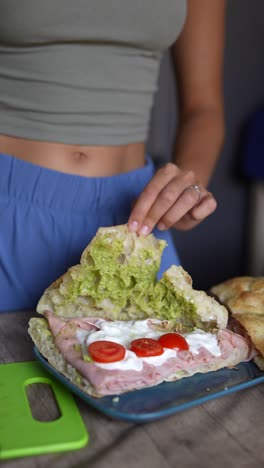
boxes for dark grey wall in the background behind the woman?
[148,0,264,289]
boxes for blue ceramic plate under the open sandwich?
[34,347,264,423]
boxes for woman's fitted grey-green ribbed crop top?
[0,0,186,145]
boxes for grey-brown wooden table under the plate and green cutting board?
[0,311,264,468]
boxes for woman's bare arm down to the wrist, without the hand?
[172,0,225,186]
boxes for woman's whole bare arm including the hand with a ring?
[128,0,225,235]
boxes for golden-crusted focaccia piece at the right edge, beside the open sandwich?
[210,276,264,370]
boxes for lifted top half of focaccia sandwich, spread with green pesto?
[37,225,227,330]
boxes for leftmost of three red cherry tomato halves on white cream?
[88,340,126,362]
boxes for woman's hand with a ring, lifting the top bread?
[128,163,217,236]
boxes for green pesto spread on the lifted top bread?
[55,229,201,331]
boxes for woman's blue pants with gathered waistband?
[0,154,179,312]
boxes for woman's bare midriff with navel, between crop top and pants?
[0,135,145,177]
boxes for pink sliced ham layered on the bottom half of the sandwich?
[45,311,252,395]
